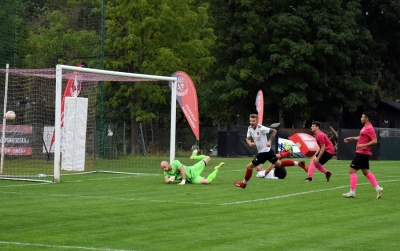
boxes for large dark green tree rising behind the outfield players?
[203,0,376,127]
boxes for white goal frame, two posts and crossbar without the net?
[53,65,178,182]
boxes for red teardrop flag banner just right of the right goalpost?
[170,71,200,140]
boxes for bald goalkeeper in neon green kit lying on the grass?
[161,155,225,185]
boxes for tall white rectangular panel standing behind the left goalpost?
[61,97,88,171]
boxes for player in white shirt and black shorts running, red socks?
[233,114,308,188]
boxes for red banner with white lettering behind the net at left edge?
[0,124,32,155]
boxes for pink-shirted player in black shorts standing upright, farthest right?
[343,112,383,199]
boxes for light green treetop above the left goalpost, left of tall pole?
[21,0,100,68]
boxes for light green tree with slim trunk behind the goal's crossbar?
[106,0,215,153]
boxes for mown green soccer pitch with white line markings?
[0,158,400,251]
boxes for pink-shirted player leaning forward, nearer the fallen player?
[305,121,335,182]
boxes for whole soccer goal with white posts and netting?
[0,65,177,182]
